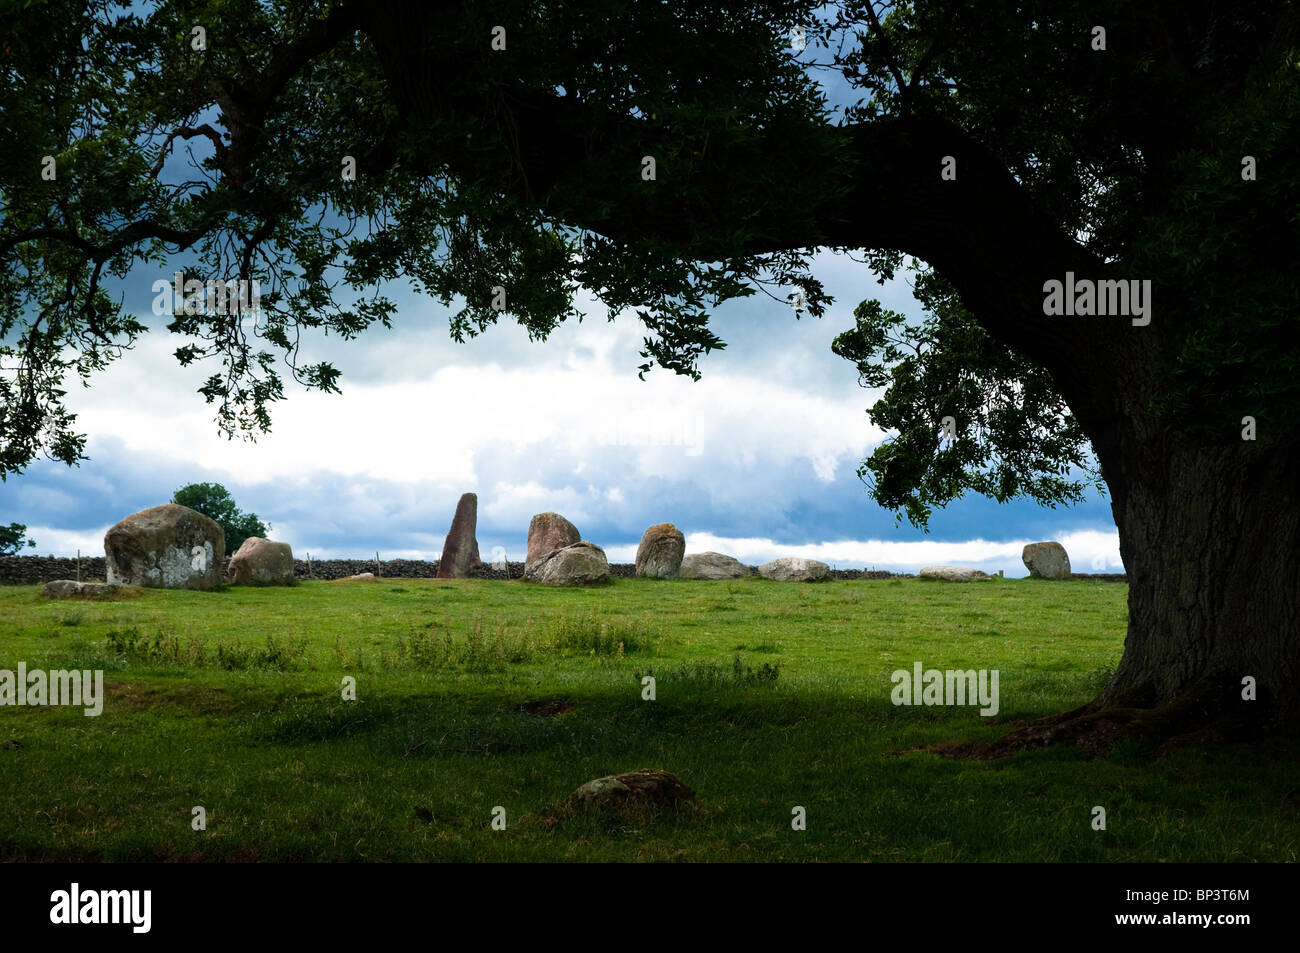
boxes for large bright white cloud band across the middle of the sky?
[69,324,883,504]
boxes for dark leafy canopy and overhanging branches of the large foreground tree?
[0,0,1300,523]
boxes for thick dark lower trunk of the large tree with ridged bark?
[1097,436,1300,736]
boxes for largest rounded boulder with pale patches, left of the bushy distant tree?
[104,503,226,589]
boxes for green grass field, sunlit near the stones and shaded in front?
[0,579,1300,861]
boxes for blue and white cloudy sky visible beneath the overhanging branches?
[0,29,1122,576]
